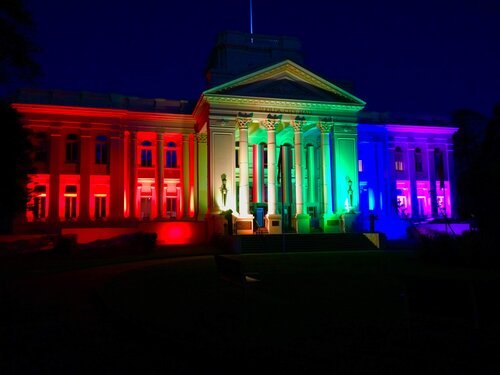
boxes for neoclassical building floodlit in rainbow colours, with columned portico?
[13,32,457,243]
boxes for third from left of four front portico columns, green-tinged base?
[292,116,310,233]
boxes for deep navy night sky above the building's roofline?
[21,0,500,115]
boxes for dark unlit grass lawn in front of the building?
[99,251,500,374]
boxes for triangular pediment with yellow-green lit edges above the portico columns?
[204,60,365,105]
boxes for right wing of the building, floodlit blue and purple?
[358,124,457,238]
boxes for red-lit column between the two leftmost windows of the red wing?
[47,130,62,223]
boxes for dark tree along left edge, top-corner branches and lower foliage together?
[0,0,40,233]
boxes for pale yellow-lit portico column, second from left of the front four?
[264,114,281,234]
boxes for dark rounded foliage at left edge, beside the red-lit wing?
[0,100,32,233]
